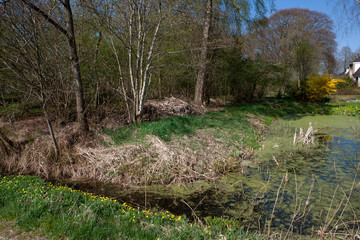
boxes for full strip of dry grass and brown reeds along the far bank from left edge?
[1,116,253,186]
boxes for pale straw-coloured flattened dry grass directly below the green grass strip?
[75,131,252,186]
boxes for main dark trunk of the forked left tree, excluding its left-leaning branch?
[63,0,89,133]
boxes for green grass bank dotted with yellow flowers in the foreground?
[0,176,260,240]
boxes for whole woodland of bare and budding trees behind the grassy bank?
[0,0,360,142]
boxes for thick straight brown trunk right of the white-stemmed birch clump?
[194,0,212,105]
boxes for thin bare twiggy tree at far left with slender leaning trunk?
[0,1,59,160]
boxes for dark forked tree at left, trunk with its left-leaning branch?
[21,0,89,134]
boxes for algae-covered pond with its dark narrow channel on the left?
[66,115,360,238]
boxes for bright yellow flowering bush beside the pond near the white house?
[306,74,344,102]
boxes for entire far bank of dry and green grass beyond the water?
[0,99,360,187]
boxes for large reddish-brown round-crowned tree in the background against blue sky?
[248,8,336,87]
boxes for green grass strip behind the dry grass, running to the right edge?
[104,99,360,147]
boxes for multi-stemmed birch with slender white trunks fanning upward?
[88,0,168,122]
